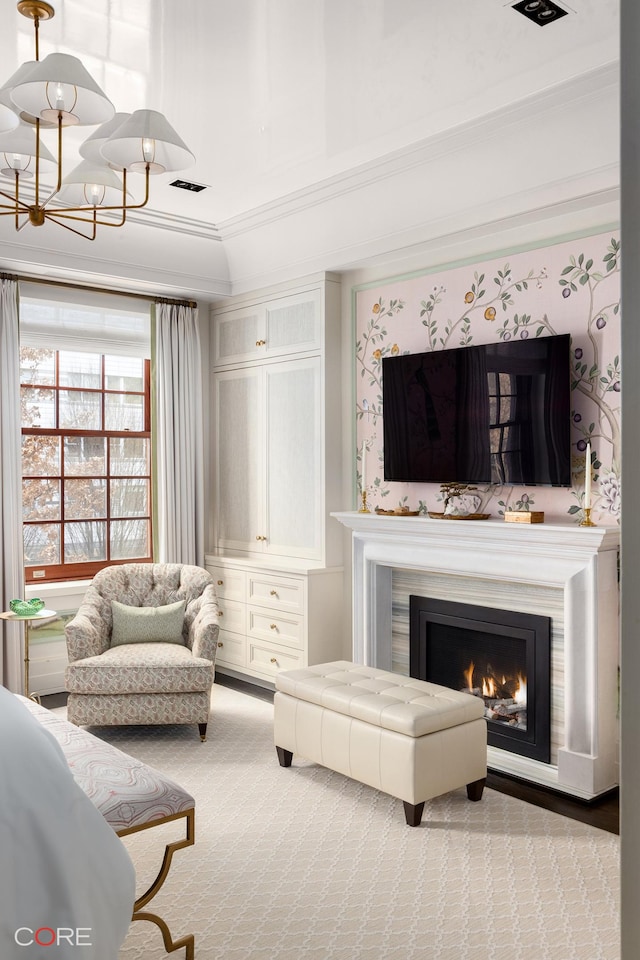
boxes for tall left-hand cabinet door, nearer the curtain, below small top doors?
[214,367,265,552]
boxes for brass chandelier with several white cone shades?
[0,0,195,240]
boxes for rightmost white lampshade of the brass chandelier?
[100,110,195,173]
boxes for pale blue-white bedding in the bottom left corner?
[0,687,135,960]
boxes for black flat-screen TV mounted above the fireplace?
[382,334,571,486]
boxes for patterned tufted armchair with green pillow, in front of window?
[65,563,219,740]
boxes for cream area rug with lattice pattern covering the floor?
[70,685,619,960]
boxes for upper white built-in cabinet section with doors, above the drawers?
[212,274,342,566]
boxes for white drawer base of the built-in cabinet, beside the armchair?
[206,555,346,682]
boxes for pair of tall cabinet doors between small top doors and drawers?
[214,356,323,560]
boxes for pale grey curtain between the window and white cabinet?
[151,303,204,566]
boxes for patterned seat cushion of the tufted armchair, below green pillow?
[65,643,213,694]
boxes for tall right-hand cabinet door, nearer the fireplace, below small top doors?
[265,357,323,559]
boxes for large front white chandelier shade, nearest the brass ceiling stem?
[10,53,115,126]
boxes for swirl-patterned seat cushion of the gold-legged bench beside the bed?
[18,697,195,832]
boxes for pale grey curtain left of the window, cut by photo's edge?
[0,280,24,693]
